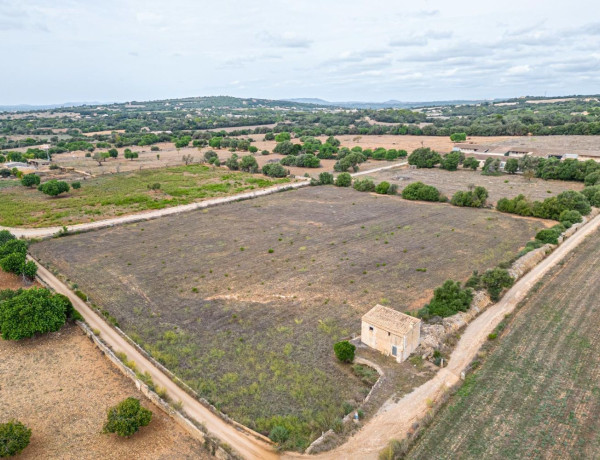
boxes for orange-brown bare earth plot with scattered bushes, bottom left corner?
[0,325,210,460]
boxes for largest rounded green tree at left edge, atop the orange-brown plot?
[0,288,68,340]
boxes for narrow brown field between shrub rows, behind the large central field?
[367,164,583,204]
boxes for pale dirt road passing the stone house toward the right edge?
[285,215,600,459]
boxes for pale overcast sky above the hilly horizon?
[0,0,600,105]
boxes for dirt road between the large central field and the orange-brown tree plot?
[30,262,279,459]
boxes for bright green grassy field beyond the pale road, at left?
[0,165,289,227]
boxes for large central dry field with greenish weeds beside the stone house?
[31,186,545,448]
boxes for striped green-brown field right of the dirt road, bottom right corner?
[409,228,600,459]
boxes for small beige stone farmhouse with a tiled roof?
[360,305,421,363]
